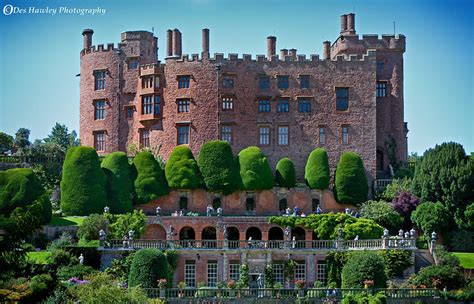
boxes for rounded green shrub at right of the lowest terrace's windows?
[341,251,387,288]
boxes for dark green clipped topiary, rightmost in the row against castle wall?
[335,152,369,205]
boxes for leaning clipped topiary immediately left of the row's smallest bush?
[237,147,275,190]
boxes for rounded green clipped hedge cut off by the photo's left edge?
[0,168,44,215]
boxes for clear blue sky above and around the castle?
[0,0,474,154]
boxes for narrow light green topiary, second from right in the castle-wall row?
[304,148,329,190]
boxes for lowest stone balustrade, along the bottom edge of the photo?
[145,288,439,300]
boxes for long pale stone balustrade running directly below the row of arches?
[101,238,416,250]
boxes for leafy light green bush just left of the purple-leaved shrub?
[360,201,403,233]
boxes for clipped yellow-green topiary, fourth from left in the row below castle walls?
[165,146,202,189]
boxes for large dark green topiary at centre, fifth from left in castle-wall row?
[198,140,240,194]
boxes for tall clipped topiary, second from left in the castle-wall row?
[101,152,133,213]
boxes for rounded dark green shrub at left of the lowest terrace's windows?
[128,248,169,288]
